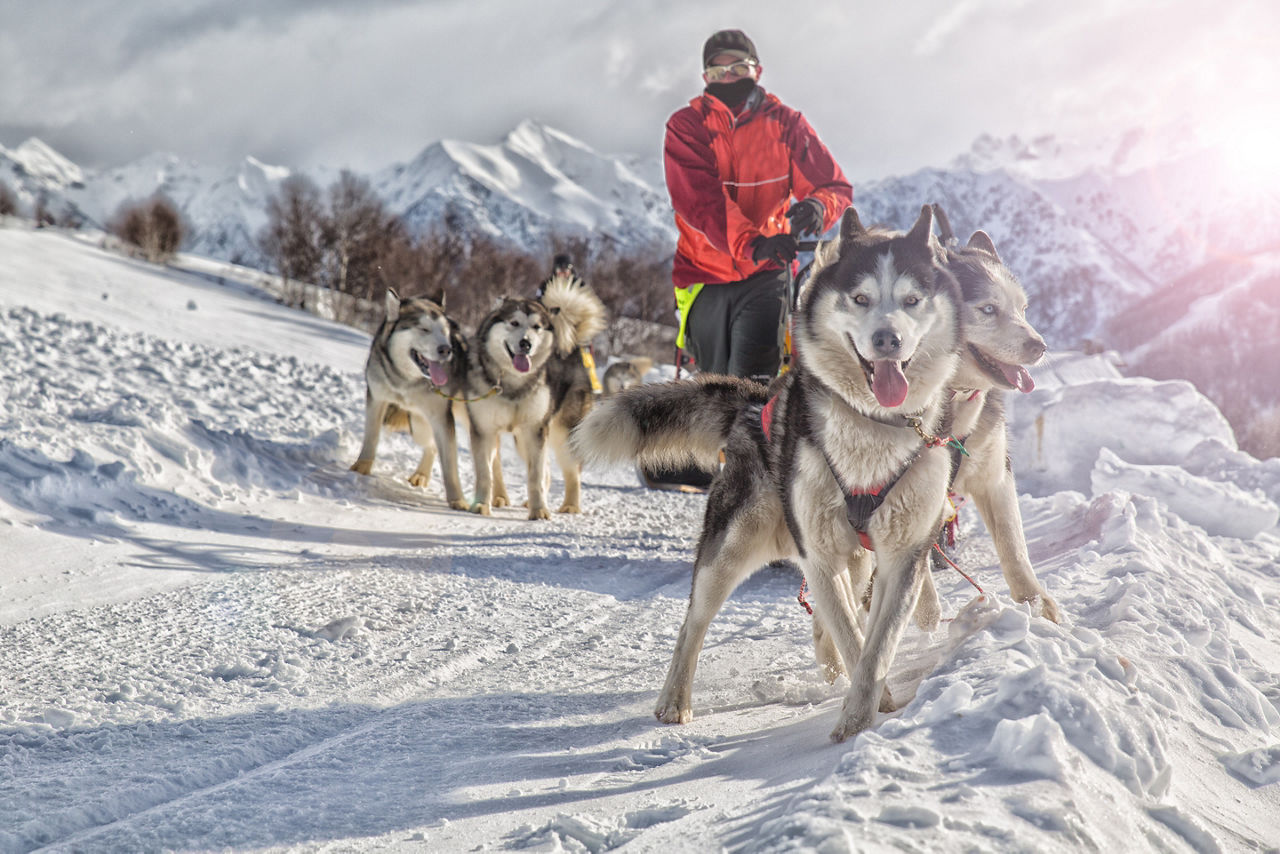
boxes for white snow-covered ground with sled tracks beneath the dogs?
[0,223,1280,851]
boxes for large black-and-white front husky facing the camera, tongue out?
[575,206,960,741]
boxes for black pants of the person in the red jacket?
[685,270,787,383]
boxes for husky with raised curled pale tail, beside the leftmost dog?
[467,269,605,519]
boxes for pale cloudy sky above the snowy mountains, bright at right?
[0,0,1280,181]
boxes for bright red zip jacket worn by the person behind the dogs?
[663,87,854,288]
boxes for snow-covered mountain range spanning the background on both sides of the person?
[0,120,1280,399]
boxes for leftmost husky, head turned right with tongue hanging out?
[351,288,468,510]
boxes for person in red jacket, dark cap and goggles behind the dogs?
[663,29,854,382]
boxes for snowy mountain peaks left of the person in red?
[0,120,675,265]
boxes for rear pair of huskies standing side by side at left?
[352,257,607,519]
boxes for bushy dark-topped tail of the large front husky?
[571,375,768,469]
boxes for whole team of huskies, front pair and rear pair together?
[353,206,1060,741]
